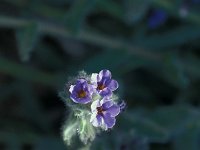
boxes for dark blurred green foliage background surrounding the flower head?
[0,0,200,150]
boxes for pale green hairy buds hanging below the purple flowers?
[62,109,96,148]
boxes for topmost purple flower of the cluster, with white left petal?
[91,70,118,97]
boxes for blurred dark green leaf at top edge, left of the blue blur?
[124,0,150,24]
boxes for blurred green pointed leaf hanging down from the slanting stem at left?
[16,23,39,61]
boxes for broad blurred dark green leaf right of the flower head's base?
[118,106,200,143]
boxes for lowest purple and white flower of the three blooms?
[90,99,120,130]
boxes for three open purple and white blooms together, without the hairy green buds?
[69,70,120,130]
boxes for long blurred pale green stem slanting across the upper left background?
[0,16,160,60]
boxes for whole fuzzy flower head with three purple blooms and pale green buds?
[59,70,126,149]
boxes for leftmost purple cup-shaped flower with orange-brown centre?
[69,79,94,104]
